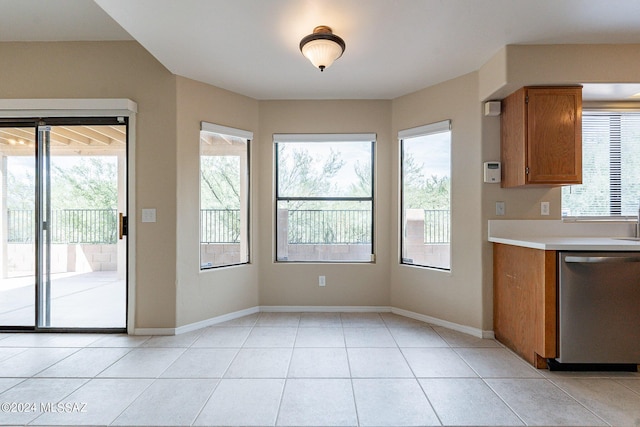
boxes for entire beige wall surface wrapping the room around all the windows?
[5,42,640,330]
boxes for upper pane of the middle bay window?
[277,142,373,198]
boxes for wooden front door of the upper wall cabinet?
[527,88,582,184]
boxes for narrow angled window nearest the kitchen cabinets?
[398,120,451,270]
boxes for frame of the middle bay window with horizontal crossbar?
[273,133,377,264]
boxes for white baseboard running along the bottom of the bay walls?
[133,305,495,339]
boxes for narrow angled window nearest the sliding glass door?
[200,122,253,270]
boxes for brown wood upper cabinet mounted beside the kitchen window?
[501,86,582,187]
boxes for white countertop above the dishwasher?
[489,220,640,251]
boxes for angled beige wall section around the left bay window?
[176,77,262,326]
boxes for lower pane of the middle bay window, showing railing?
[276,200,372,262]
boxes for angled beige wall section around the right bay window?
[391,73,483,328]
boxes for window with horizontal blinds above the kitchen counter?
[562,110,640,218]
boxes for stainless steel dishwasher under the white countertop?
[557,252,640,364]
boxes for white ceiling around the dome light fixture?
[0,0,640,99]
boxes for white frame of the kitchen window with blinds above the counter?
[560,108,640,222]
